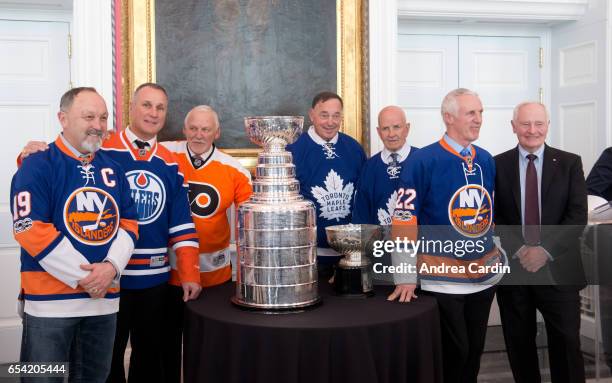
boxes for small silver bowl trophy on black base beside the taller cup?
[325,224,382,296]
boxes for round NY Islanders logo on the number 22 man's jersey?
[448,184,493,238]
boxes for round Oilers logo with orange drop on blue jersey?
[125,170,166,225]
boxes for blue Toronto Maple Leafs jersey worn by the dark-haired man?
[287,128,366,255]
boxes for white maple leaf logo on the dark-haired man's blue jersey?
[311,169,353,221]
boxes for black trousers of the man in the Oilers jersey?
[107,283,168,383]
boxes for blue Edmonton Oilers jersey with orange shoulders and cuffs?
[102,131,200,289]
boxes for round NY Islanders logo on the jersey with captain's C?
[64,187,119,246]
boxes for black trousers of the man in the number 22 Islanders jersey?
[421,286,495,383]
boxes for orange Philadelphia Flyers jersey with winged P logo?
[162,141,252,287]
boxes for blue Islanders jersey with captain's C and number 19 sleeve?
[11,137,138,317]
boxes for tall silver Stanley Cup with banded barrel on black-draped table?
[232,116,319,310]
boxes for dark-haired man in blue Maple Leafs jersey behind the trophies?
[287,92,366,268]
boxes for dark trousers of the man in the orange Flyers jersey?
[164,285,185,383]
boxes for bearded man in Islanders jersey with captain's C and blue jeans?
[11,88,138,382]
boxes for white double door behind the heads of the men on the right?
[397,34,540,155]
